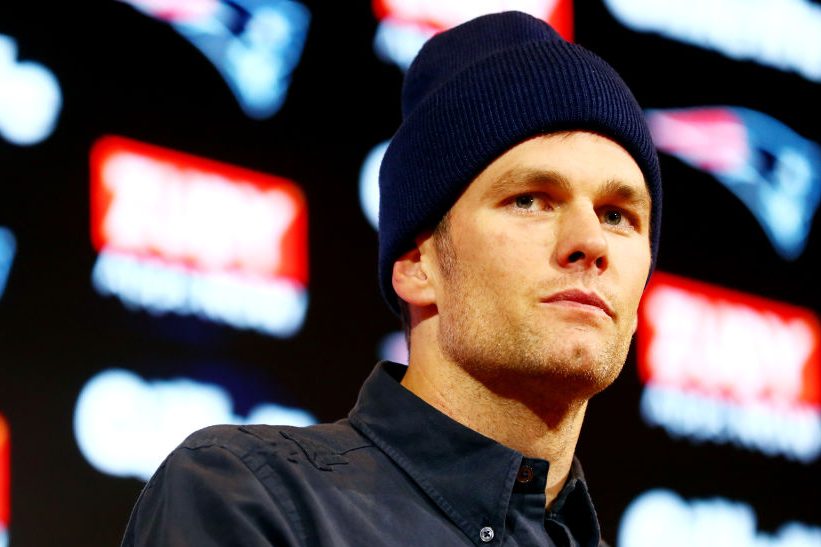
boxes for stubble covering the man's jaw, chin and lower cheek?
[433,225,632,403]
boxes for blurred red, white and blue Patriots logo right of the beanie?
[647,107,821,260]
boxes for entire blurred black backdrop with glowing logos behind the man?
[0,0,821,547]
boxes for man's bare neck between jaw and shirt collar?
[402,348,587,506]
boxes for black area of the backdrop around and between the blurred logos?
[0,0,821,547]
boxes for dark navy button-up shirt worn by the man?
[123,362,600,547]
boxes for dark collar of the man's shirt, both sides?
[349,361,599,539]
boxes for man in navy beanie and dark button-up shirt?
[123,12,661,547]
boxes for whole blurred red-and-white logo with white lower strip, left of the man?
[91,137,308,336]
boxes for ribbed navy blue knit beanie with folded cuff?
[379,12,661,314]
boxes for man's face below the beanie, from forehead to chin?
[426,132,650,397]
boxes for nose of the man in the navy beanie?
[556,204,608,271]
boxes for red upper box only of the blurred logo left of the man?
[91,137,308,285]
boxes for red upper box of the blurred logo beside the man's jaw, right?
[637,273,821,410]
